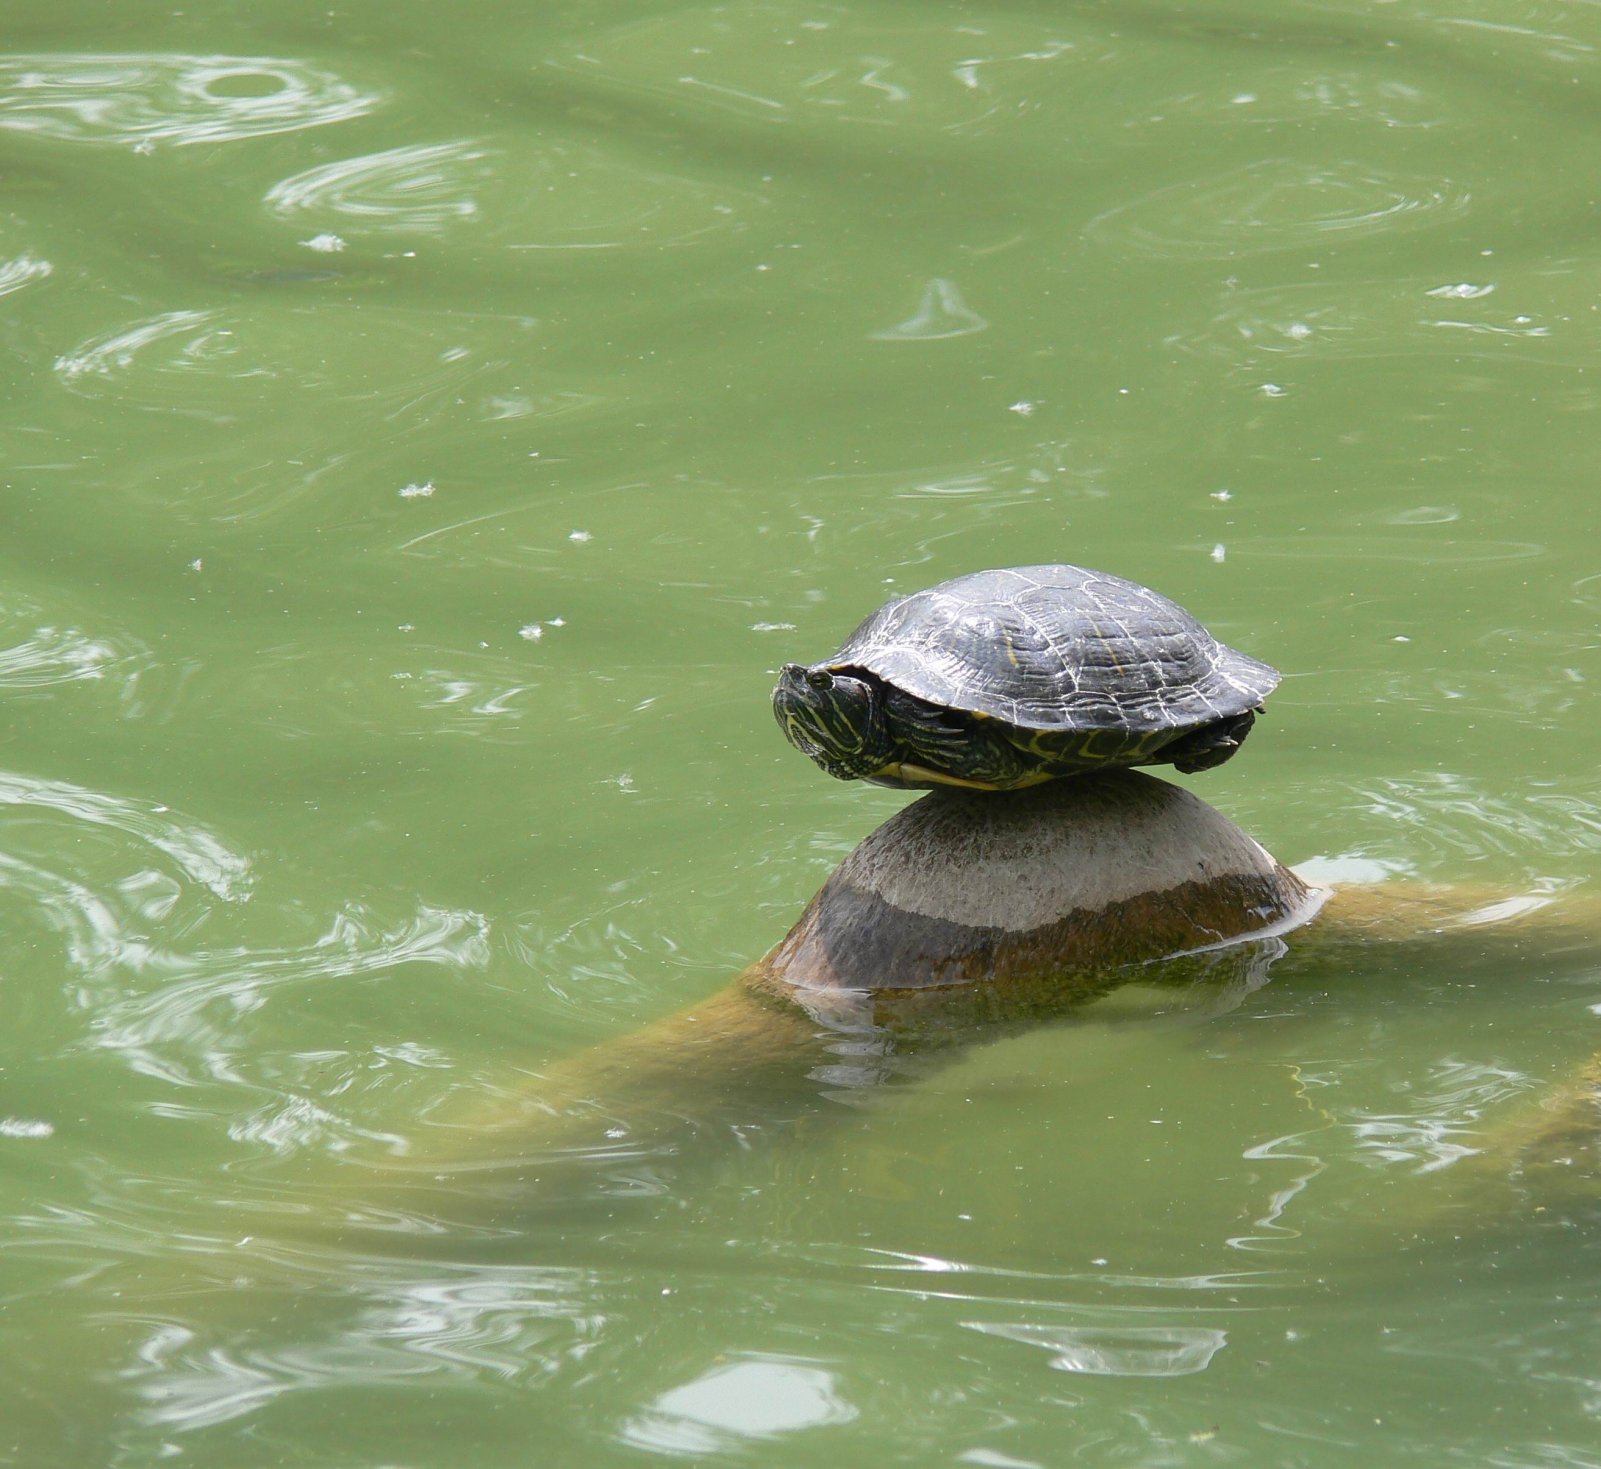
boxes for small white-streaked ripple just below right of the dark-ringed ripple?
[267,142,492,230]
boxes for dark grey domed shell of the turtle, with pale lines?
[825,566,1279,735]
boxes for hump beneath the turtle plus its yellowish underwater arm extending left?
[415,770,1327,1168]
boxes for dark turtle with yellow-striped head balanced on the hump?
[773,565,1279,791]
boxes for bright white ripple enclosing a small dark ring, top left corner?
[0,51,378,144]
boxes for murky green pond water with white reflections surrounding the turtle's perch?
[9,0,1601,1469]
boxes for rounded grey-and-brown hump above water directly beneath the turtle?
[743,770,1326,1027]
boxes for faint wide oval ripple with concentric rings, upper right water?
[1089,158,1468,259]
